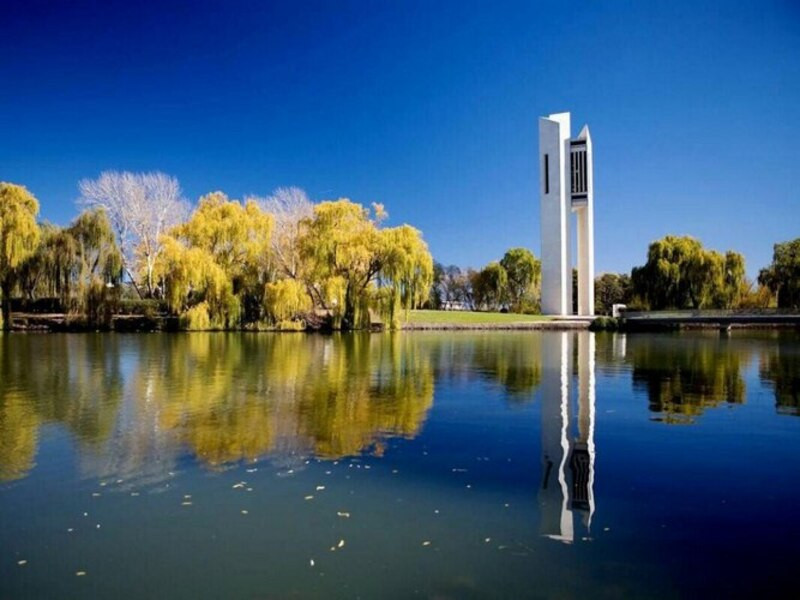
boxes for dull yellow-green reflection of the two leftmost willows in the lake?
[0,335,122,480]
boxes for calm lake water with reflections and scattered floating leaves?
[0,332,800,598]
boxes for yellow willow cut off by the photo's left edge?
[0,182,39,330]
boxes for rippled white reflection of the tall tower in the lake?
[539,331,595,544]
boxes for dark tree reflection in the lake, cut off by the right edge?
[759,334,800,415]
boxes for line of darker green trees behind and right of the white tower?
[434,236,800,315]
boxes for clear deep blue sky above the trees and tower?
[0,0,800,275]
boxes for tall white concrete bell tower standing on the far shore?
[539,113,594,316]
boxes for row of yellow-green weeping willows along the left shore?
[6,180,433,329]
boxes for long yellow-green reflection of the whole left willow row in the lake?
[0,333,433,480]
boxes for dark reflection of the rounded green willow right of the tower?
[628,332,747,423]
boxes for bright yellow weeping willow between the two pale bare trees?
[156,192,273,329]
